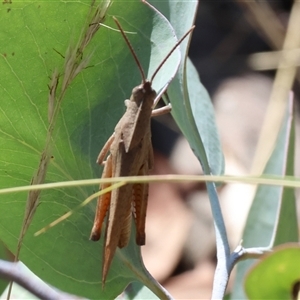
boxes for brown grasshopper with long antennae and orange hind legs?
[90,18,194,285]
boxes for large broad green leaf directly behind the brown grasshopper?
[0,1,195,298]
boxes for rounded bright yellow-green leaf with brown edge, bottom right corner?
[245,244,300,299]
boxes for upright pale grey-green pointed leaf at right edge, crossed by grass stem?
[232,101,298,299]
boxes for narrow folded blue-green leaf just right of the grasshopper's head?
[153,1,224,175]
